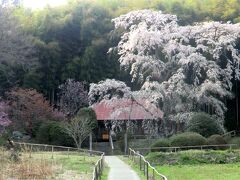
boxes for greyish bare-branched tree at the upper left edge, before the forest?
[0,6,37,95]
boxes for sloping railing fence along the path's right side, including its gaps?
[128,148,167,180]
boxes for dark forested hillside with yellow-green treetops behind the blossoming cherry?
[0,0,240,134]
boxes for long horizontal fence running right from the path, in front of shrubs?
[131,144,237,154]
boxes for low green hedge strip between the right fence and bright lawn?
[146,150,240,165]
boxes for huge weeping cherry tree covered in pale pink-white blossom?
[89,10,240,134]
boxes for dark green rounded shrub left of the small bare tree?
[37,121,74,146]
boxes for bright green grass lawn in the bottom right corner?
[156,163,240,180]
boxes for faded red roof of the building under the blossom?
[92,99,163,120]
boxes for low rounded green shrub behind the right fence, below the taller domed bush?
[170,132,207,146]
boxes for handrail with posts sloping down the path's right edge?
[129,148,167,180]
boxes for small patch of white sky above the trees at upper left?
[23,0,68,9]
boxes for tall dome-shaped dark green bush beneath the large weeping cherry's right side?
[186,113,223,137]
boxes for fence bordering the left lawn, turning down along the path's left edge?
[13,142,104,180]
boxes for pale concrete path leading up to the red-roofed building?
[105,156,140,180]
